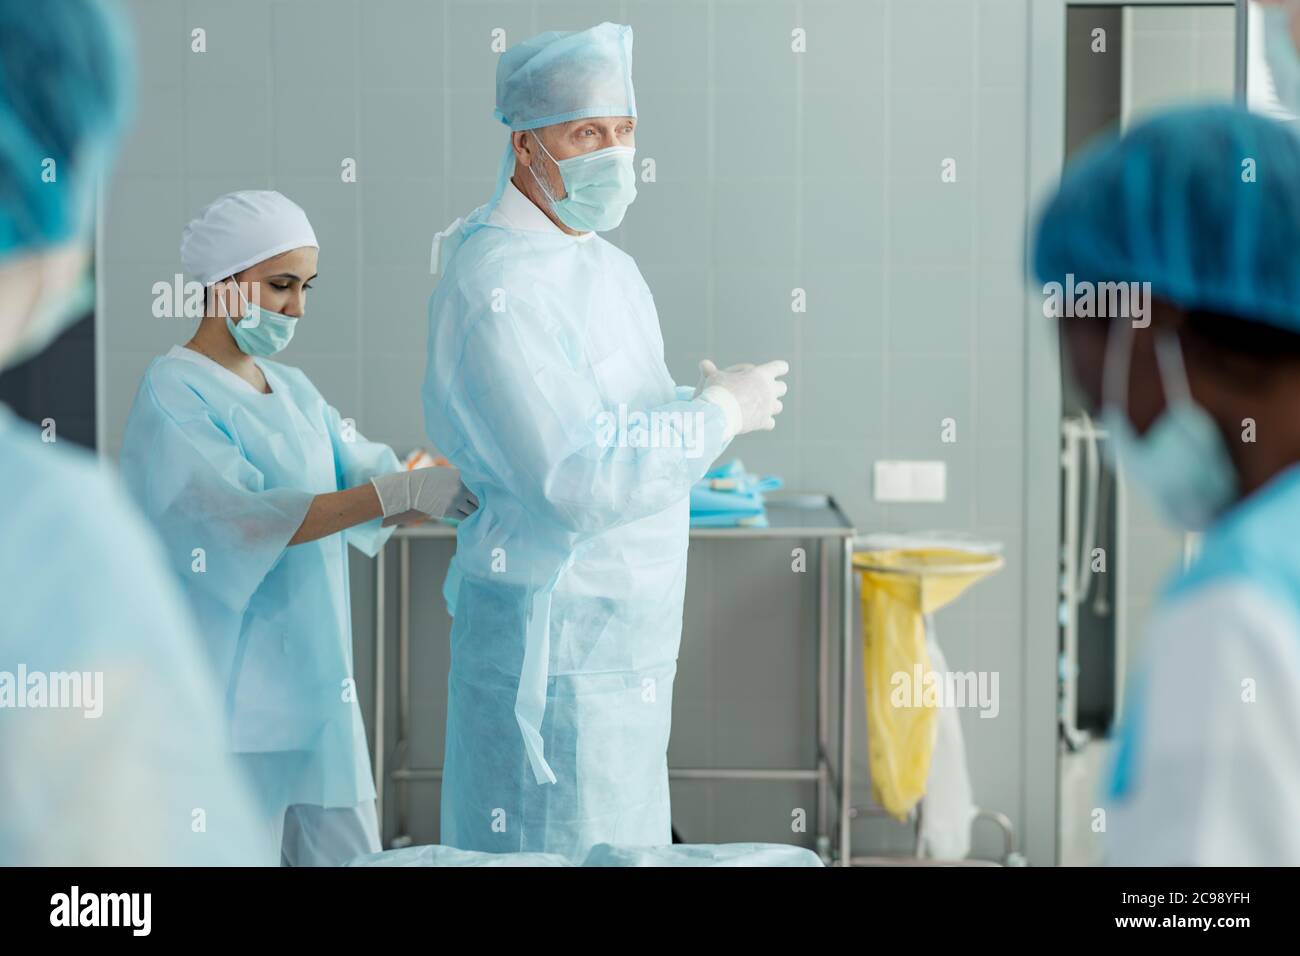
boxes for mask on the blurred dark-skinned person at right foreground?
[1101,323,1238,531]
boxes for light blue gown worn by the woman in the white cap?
[122,349,400,809]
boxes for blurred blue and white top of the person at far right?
[1106,466,1300,866]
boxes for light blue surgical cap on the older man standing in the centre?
[497,23,637,130]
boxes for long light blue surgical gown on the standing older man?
[424,186,728,857]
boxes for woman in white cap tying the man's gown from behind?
[122,191,477,865]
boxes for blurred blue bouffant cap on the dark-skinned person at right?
[1031,105,1300,332]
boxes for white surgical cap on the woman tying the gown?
[181,190,320,285]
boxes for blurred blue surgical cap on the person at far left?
[0,0,131,260]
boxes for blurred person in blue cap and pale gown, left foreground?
[0,0,256,865]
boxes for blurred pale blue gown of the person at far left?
[0,406,260,866]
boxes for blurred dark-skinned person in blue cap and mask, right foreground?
[1031,107,1300,865]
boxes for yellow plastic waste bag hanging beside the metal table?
[853,548,1002,819]
